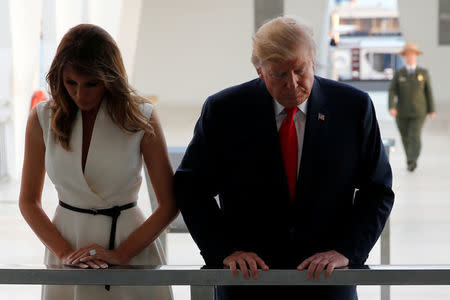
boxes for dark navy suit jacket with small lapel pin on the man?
[175,76,394,268]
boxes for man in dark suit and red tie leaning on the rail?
[174,17,394,300]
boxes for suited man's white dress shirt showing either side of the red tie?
[273,99,308,178]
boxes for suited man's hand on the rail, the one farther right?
[297,250,349,280]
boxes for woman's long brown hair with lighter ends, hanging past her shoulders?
[47,24,153,151]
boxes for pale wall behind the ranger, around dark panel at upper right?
[398,0,450,104]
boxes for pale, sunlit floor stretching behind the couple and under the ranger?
[0,93,450,300]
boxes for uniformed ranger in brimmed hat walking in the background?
[389,43,435,172]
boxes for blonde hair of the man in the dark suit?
[251,17,317,69]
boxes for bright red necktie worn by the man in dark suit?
[279,107,298,201]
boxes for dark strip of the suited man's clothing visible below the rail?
[216,279,358,300]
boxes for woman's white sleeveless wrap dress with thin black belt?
[37,101,172,300]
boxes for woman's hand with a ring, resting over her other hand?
[71,244,128,267]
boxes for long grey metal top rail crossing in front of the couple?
[0,265,450,286]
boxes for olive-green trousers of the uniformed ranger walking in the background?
[395,116,426,163]
